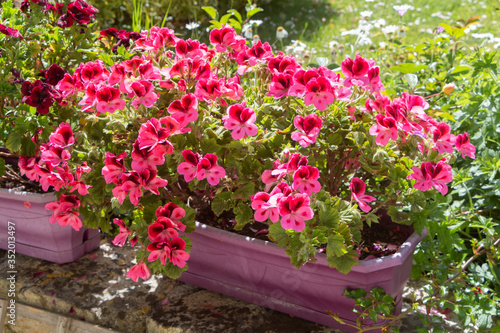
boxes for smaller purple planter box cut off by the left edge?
[0,189,101,264]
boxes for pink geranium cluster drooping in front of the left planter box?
[19,123,91,230]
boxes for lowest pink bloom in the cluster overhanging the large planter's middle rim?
[278,193,314,231]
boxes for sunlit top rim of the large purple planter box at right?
[193,221,427,273]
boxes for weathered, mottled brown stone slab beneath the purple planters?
[0,235,468,333]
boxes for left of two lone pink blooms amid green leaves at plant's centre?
[222,103,259,140]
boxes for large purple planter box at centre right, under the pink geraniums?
[179,222,427,332]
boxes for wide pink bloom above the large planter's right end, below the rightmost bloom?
[407,161,453,195]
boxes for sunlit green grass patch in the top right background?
[294,0,500,62]
